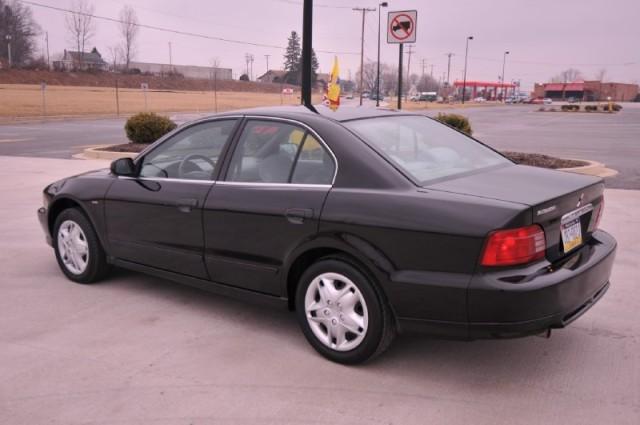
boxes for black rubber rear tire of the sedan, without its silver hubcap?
[295,257,396,364]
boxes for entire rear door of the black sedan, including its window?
[203,119,336,295]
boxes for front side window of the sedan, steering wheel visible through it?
[140,119,236,180]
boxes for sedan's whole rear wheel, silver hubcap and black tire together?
[296,258,395,364]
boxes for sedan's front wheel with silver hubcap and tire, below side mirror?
[54,208,109,283]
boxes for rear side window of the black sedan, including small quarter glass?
[226,120,335,184]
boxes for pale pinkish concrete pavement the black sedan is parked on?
[0,157,640,425]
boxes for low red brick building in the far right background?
[533,81,640,102]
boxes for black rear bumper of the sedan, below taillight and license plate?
[399,230,617,339]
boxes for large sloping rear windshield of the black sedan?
[344,116,511,184]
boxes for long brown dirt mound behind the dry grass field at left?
[0,69,299,93]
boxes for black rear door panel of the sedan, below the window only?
[204,182,330,295]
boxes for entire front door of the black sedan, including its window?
[105,118,238,279]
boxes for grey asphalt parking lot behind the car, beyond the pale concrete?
[0,101,640,190]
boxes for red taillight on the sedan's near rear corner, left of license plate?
[481,224,547,266]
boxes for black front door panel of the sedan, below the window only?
[106,177,213,279]
